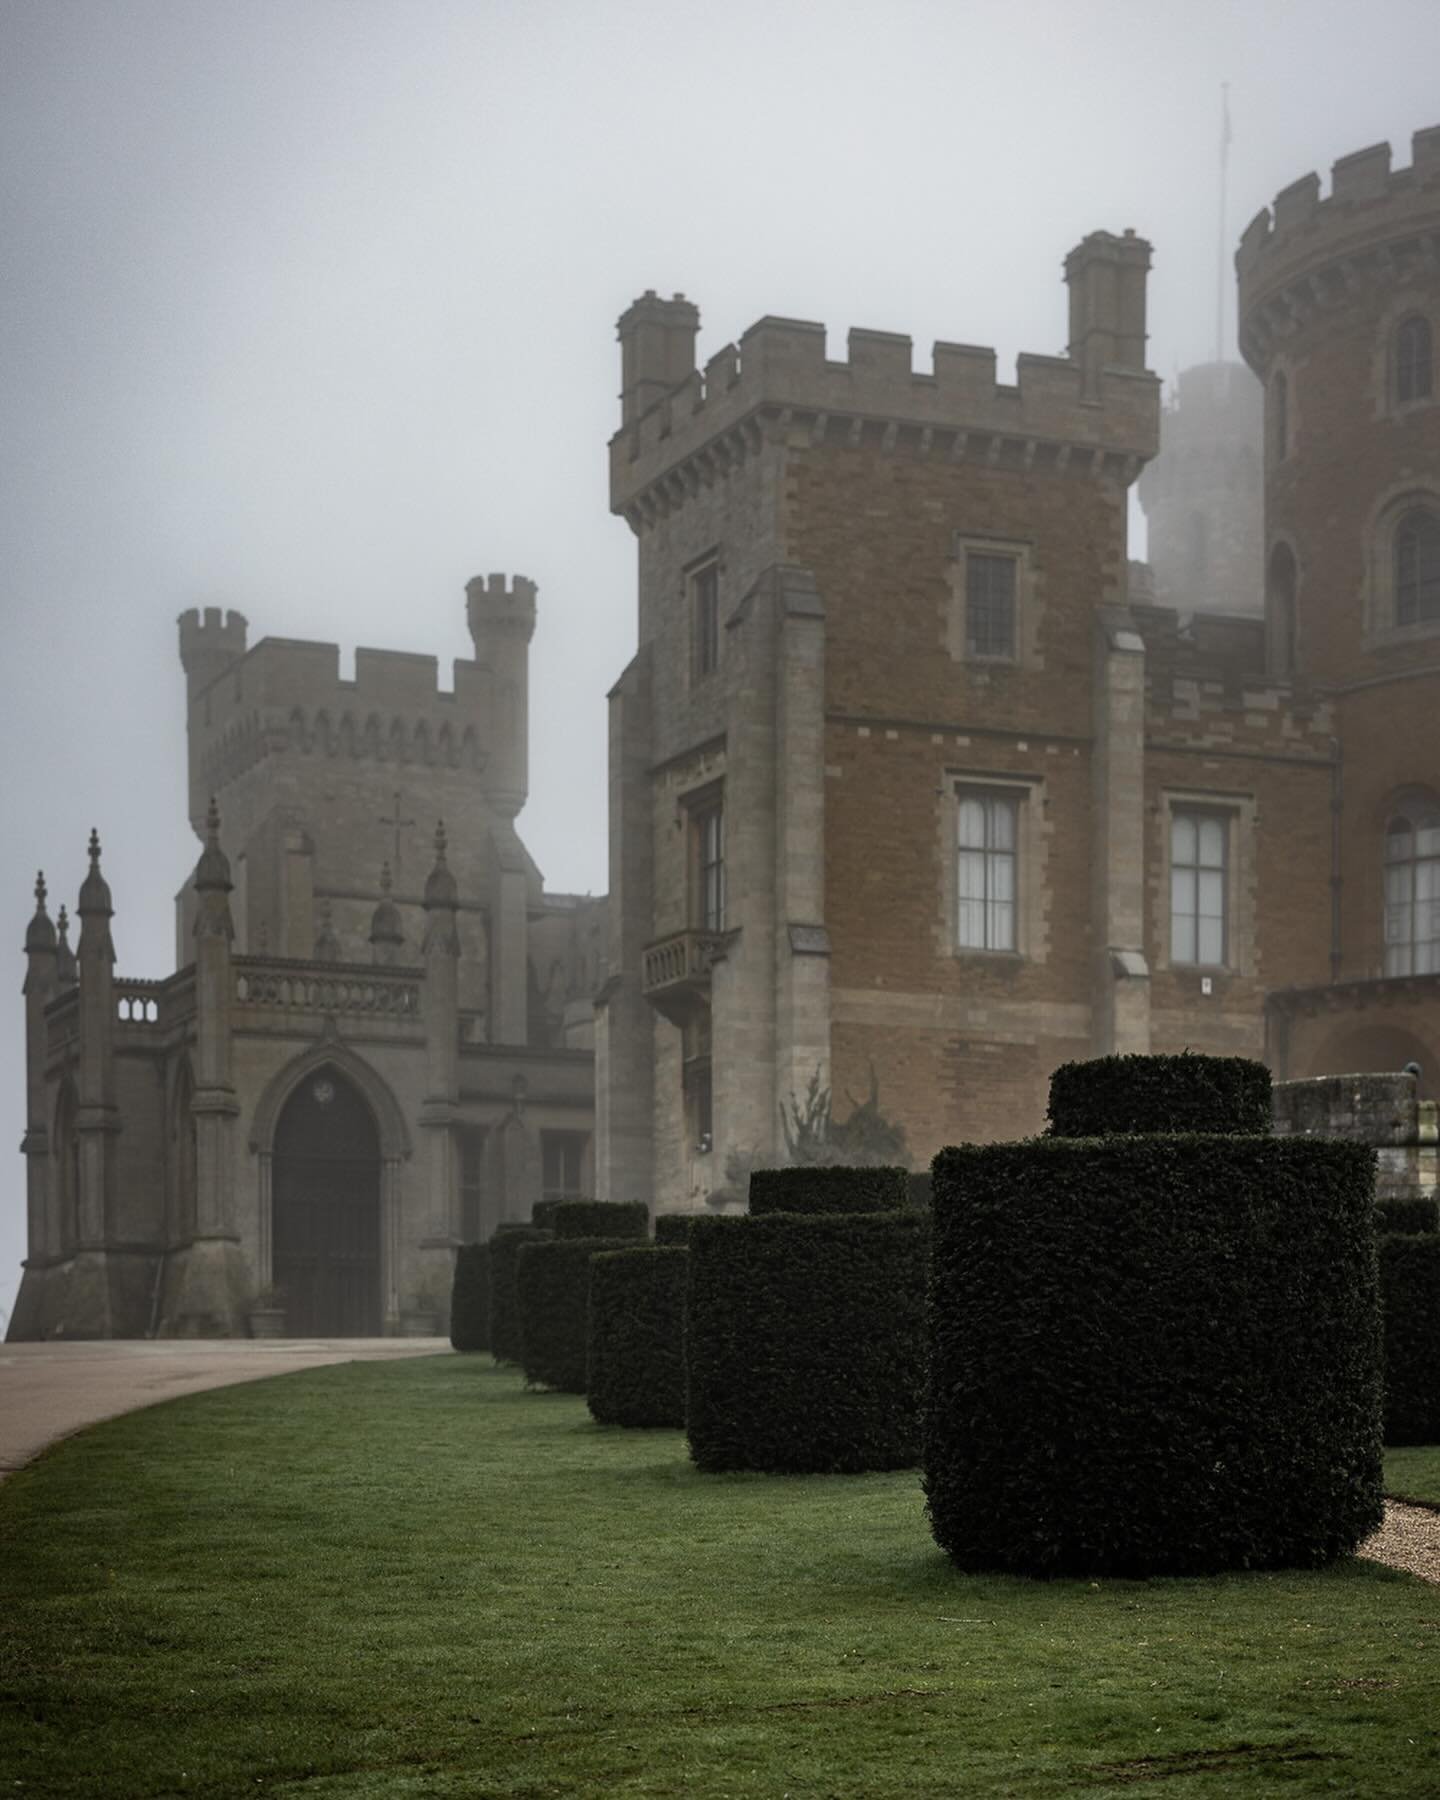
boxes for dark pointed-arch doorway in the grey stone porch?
[272,1066,382,1337]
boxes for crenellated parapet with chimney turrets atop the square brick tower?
[610,232,1159,524]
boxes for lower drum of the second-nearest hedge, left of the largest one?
[686,1210,929,1474]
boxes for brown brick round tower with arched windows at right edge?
[1235,126,1440,981]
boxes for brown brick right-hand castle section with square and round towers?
[596,128,1440,1208]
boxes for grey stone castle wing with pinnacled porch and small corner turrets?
[9,574,605,1337]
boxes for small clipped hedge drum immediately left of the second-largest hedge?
[585,1244,689,1427]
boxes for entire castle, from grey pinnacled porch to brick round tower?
[11,116,1440,1337]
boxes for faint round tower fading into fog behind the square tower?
[1138,362,1264,614]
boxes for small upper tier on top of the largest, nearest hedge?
[1049,1051,1271,1138]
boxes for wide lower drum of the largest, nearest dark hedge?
[925,1136,1381,1575]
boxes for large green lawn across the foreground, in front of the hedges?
[0,1357,1440,1800]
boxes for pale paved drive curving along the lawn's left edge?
[0,1337,450,1478]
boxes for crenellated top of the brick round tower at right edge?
[1235,126,1440,362]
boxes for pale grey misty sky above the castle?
[0,0,1440,1307]
